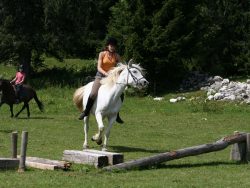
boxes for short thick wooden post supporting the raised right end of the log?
[230,131,246,162]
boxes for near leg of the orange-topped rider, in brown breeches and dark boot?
[78,78,101,120]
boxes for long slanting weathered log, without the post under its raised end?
[103,133,246,171]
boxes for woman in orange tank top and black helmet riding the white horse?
[79,37,124,123]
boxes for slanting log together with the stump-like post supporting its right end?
[103,131,250,171]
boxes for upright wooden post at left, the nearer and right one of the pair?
[18,131,28,172]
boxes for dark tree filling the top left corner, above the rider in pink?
[0,0,44,73]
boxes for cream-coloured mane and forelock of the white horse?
[101,63,144,86]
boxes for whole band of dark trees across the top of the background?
[0,0,250,91]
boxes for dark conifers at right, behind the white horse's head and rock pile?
[108,0,250,92]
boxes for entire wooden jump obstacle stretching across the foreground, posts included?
[0,131,250,172]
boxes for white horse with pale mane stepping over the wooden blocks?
[73,61,148,151]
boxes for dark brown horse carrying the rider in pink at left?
[0,79,43,117]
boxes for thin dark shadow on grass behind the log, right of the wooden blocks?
[109,146,168,153]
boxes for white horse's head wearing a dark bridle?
[125,60,149,89]
